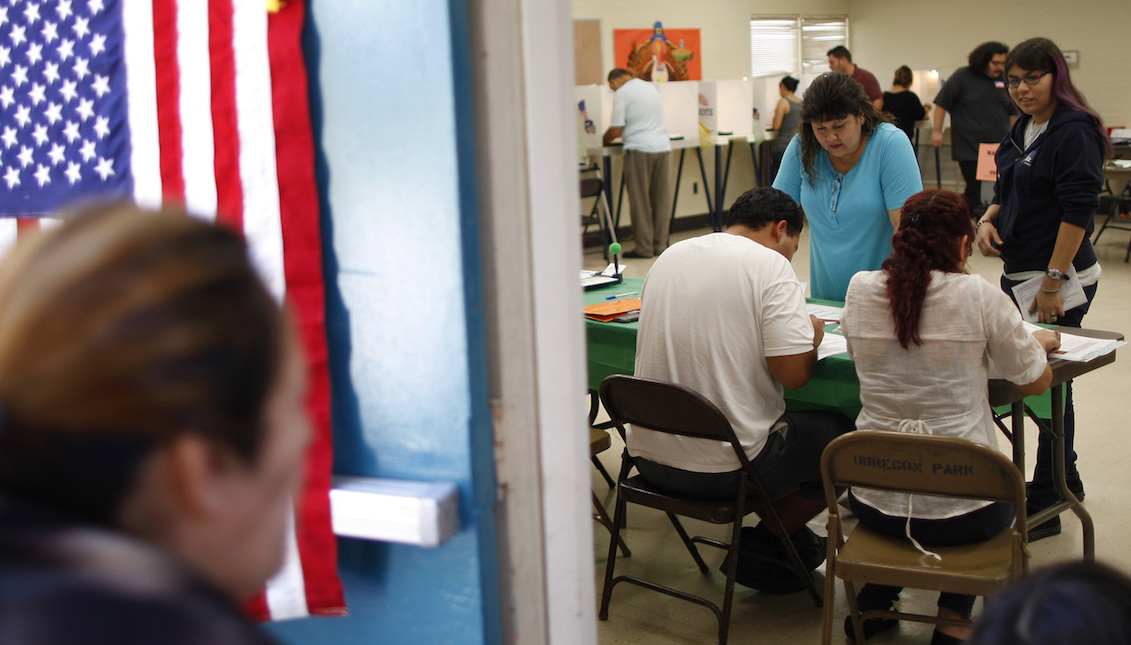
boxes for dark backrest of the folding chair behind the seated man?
[599,375,748,467]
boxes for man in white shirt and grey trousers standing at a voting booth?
[603,68,672,258]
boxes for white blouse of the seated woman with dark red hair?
[840,270,1048,519]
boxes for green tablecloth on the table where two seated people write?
[585,277,1052,419]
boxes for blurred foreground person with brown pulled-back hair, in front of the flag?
[0,205,310,645]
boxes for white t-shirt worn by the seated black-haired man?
[628,233,813,466]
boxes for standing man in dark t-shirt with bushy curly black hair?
[931,42,1017,217]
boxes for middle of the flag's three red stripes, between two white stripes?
[208,0,243,230]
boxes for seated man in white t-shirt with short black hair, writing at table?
[628,188,853,591]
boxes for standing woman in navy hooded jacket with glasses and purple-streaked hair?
[977,38,1111,541]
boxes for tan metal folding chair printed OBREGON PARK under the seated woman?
[821,430,1029,645]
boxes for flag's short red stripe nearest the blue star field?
[153,0,184,204]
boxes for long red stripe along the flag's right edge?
[267,0,346,616]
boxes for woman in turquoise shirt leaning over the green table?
[774,71,923,300]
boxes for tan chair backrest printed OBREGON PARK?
[821,430,1025,506]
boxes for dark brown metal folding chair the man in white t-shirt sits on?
[598,376,821,645]
